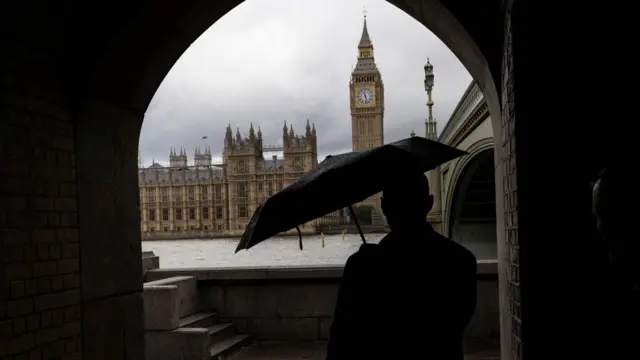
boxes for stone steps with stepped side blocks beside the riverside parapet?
[143,276,250,360]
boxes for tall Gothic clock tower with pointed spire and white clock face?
[349,13,384,211]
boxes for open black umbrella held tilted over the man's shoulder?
[236,136,467,252]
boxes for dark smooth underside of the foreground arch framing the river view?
[56,0,502,358]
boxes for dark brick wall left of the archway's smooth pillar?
[0,54,81,360]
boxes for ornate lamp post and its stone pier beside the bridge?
[424,59,442,233]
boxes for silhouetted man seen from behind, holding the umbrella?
[327,171,477,360]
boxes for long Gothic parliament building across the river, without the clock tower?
[139,120,340,238]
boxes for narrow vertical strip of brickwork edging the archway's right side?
[494,2,523,360]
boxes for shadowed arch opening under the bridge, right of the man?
[449,149,498,260]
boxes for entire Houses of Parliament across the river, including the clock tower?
[138,17,384,238]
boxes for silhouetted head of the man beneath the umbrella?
[382,170,433,228]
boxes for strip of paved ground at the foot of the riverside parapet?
[227,342,500,360]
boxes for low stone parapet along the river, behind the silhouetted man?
[145,260,500,348]
